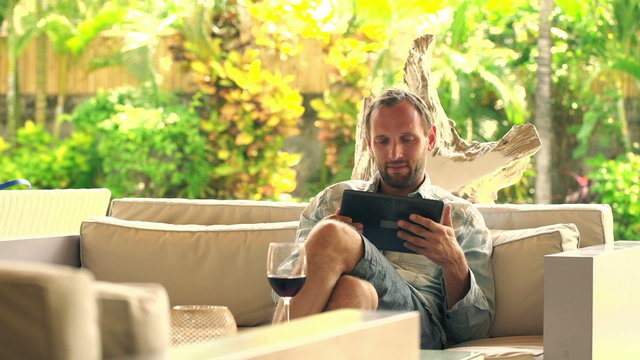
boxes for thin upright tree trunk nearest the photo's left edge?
[7,0,20,144]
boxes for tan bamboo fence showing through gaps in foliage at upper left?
[0,35,327,95]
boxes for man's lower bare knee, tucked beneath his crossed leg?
[326,275,378,310]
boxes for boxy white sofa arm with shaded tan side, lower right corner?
[544,241,640,360]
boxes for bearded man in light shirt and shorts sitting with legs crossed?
[275,89,494,349]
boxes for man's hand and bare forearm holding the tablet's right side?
[398,205,471,308]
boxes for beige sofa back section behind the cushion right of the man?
[474,204,614,247]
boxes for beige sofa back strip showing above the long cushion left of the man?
[110,198,306,225]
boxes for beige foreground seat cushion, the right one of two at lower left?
[94,281,170,359]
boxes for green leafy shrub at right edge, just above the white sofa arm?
[589,153,640,240]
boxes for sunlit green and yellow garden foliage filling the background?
[0,0,640,239]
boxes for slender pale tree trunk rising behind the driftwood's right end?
[535,0,554,204]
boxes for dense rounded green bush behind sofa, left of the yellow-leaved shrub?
[98,105,209,198]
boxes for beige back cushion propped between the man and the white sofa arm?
[491,224,580,337]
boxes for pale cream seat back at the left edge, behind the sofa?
[0,189,111,240]
